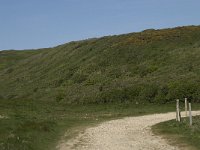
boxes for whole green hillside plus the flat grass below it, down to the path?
[0,26,200,150]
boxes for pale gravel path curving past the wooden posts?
[57,111,200,150]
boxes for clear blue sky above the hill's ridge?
[0,0,200,50]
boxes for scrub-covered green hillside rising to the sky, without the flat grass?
[0,26,200,104]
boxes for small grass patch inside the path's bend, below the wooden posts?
[153,116,200,150]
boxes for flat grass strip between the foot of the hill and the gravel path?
[0,100,174,150]
